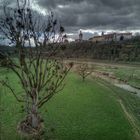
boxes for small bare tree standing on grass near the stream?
[77,64,92,82]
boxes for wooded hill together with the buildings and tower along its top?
[0,32,140,62]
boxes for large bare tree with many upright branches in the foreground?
[0,0,73,135]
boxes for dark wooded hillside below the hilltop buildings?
[0,38,140,62]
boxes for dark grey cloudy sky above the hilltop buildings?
[0,0,140,38]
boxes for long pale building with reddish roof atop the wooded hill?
[89,33,132,43]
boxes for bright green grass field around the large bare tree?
[0,70,138,140]
